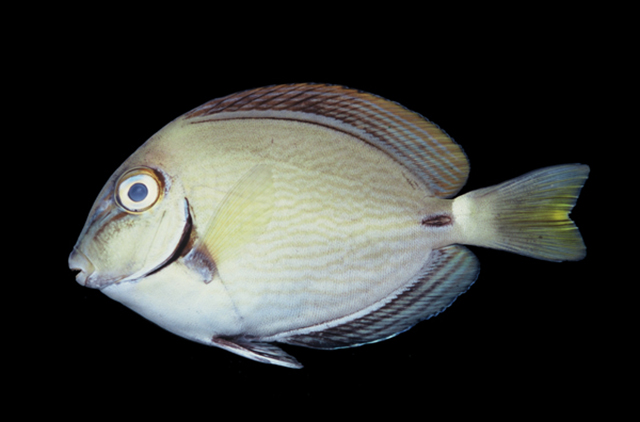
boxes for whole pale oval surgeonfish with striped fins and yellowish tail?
[69,84,590,368]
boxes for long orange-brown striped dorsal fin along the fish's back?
[183,84,469,198]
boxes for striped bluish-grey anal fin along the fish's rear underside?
[276,245,480,349]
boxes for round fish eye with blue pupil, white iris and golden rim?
[116,168,162,213]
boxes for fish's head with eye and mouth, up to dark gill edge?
[69,162,191,289]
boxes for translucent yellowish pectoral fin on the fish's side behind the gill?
[194,164,275,278]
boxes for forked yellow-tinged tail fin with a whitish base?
[453,164,589,261]
